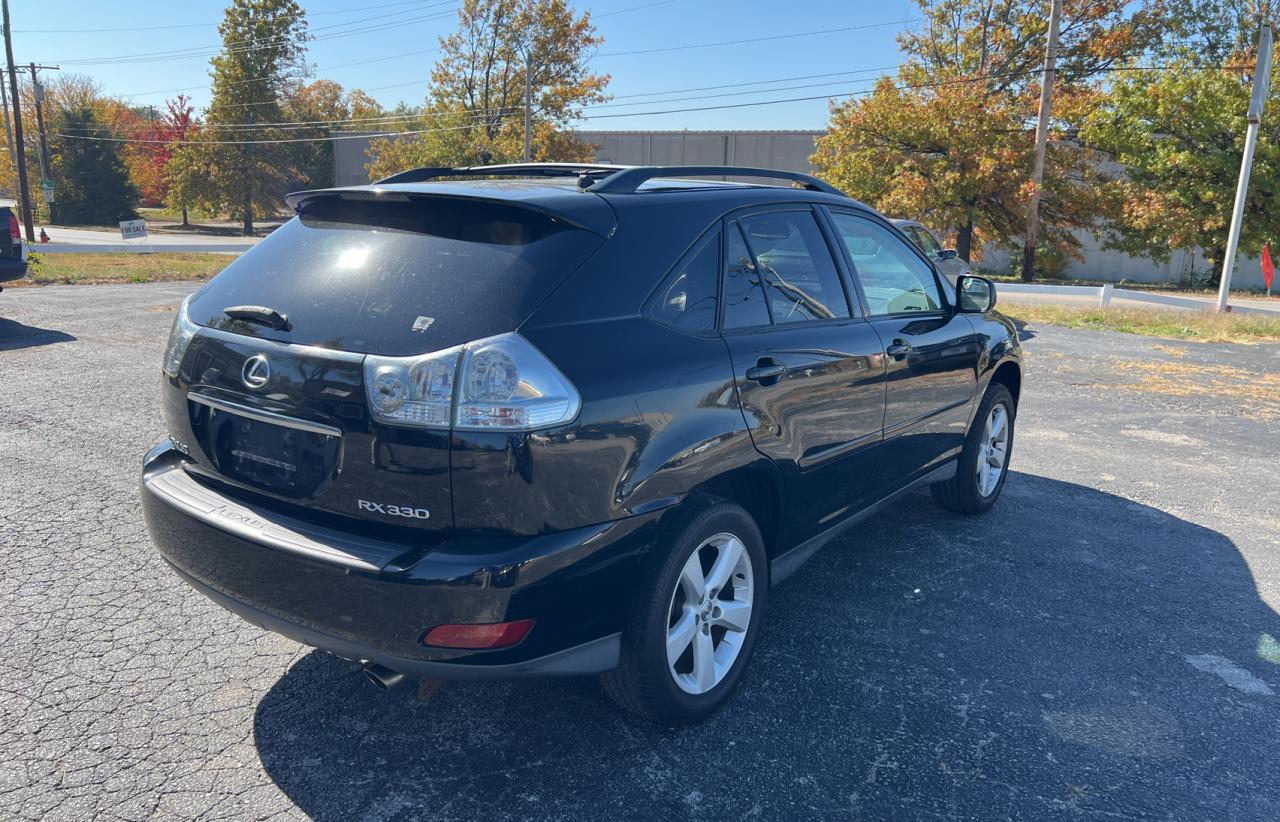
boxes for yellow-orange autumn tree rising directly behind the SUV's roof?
[367,0,609,178]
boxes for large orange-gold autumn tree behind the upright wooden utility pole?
[813,0,1158,270]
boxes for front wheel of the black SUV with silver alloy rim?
[931,383,1018,513]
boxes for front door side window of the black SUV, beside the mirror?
[831,213,942,315]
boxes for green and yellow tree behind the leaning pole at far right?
[1082,0,1280,279]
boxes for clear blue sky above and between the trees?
[10,0,919,131]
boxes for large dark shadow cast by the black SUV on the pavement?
[253,472,1280,821]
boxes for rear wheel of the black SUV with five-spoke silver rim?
[600,502,769,726]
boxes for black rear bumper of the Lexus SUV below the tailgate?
[142,446,660,679]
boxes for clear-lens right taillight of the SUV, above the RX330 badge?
[365,334,581,431]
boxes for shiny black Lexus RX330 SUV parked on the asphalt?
[142,164,1021,725]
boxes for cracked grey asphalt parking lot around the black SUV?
[0,284,1280,821]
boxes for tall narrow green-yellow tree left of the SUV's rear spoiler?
[170,0,308,234]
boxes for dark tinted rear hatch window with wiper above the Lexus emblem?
[189,197,603,356]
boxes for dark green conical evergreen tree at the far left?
[54,105,138,225]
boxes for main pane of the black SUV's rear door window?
[742,211,849,325]
